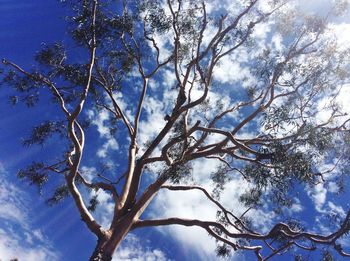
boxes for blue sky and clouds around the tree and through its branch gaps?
[0,0,350,261]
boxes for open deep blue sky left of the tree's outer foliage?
[0,0,100,260]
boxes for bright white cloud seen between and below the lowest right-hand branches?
[147,157,274,260]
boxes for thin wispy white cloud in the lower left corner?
[0,163,59,261]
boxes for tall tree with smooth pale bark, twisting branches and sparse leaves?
[2,0,350,260]
